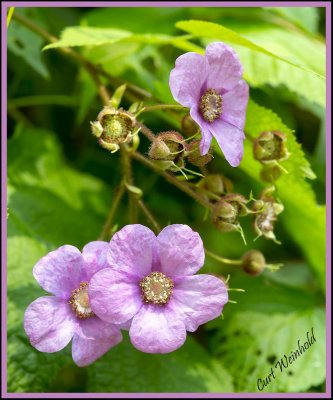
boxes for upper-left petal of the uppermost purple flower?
[169,53,207,107]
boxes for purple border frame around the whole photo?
[1,1,332,398]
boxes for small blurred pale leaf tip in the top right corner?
[265,7,319,33]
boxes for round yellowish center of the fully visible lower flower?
[140,272,173,304]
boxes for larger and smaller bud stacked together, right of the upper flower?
[253,130,290,182]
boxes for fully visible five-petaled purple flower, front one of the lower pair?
[89,225,228,353]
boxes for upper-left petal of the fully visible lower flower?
[107,224,156,278]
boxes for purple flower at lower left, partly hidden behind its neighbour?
[24,242,122,367]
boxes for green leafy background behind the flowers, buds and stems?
[8,7,325,392]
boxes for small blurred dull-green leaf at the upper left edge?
[7,21,50,79]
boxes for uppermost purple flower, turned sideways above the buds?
[169,42,249,167]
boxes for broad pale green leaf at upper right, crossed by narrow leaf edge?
[223,24,326,107]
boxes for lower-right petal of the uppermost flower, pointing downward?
[211,119,245,167]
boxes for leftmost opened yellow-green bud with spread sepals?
[90,106,136,153]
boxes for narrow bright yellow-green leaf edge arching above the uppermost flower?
[176,20,324,78]
